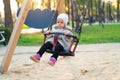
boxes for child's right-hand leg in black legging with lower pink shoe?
[49,43,64,66]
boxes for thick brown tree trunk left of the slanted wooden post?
[3,0,13,28]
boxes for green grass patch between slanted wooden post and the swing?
[17,33,44,46]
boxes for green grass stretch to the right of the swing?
[80,24,120,44]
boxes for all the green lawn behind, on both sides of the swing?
[17,24,120,46]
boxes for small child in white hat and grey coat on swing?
[30,13,72,66]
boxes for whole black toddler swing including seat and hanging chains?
[40,0,86,56]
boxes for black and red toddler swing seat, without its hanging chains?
[43,32,79,56]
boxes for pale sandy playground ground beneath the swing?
[0,43,120,80]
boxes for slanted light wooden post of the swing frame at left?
[0,0,32,73]
